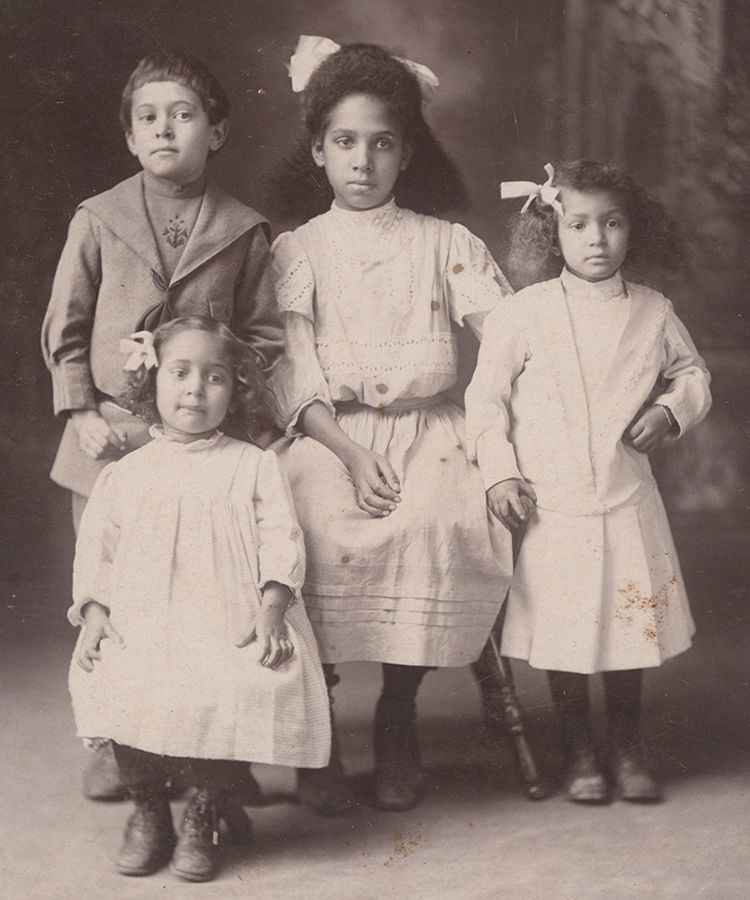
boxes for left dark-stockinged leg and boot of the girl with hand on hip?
[548,672,610,804]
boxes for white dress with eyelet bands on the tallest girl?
[271,202,511,666]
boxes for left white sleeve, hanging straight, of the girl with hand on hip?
[466,298,528,490]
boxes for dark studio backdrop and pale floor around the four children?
[0,0,750,900]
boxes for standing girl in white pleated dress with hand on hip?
[466,161,711,803]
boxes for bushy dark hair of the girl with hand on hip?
[507,159,683,287]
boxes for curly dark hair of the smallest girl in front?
[117,316,270,438]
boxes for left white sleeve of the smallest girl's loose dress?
[68,463,120,625]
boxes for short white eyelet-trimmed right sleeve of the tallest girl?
[445,225,513,338]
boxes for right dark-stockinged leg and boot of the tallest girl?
[373,664,428,812]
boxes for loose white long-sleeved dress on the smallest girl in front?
[68,429,330,768]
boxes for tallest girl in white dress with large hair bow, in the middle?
[271,38,511,813]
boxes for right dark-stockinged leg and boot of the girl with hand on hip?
[604,669,664,803]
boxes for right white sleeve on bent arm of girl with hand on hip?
[654,303,711,436]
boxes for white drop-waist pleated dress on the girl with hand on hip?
[466,270,711,674]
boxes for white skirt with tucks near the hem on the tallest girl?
[279,397,512,666]
